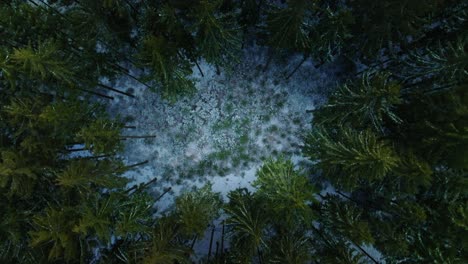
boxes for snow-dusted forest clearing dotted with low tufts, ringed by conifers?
[109,44,346,212]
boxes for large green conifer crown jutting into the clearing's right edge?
[304,128,399,190]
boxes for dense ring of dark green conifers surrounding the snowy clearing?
[0,0,468,264]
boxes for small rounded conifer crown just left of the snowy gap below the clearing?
[175,184,222,237]
